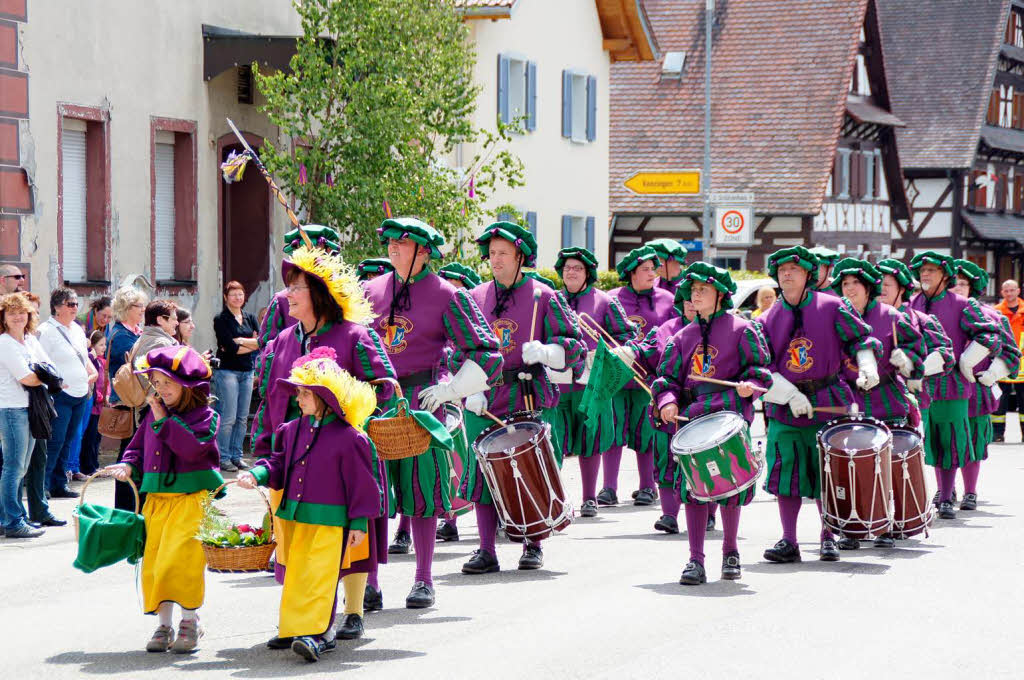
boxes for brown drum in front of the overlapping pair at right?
[817,416,893,539]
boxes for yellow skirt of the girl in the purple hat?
[142,491,208,613]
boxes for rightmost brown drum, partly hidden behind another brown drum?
[891,427,935,539]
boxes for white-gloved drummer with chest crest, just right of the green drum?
[759,246,882,562]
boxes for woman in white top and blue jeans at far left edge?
[0,294,49,539]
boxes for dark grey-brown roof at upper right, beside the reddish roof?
[877,0,1011,169]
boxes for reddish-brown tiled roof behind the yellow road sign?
[609,0,868,215]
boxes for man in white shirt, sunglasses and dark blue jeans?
[39,287,97,498]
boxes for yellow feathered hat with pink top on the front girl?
[279,347,377,430]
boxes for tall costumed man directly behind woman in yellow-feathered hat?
[366,217,502,608]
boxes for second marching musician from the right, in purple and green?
[910,251,1001,519]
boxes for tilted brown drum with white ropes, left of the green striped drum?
[473,411,572,542]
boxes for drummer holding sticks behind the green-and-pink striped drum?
[653,262,772,586]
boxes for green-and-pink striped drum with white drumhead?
[669,411,765,502]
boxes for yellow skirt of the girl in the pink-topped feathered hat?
[278,519,370,637]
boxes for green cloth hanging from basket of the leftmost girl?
[74,503,145,573]
